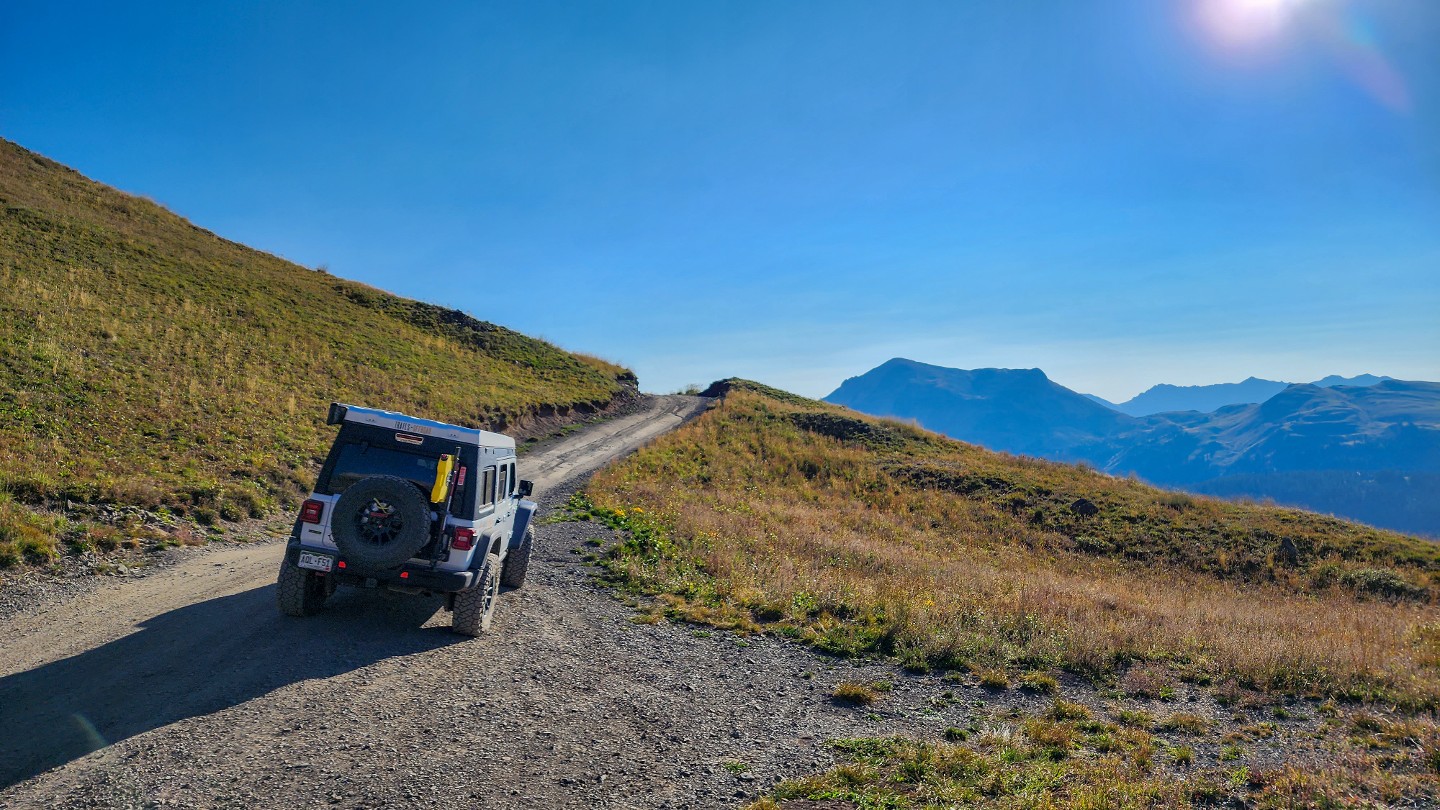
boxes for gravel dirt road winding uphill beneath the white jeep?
[0,389,990,807]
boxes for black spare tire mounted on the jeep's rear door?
[330,476,431,572]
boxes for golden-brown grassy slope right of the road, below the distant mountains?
[577,382,1440,709]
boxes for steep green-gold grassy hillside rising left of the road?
[0,141,634,566]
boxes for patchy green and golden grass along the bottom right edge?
[747,718,1437,810]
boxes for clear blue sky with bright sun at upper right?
[0,0,1440,399]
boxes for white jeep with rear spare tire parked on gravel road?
[276,404,536,636]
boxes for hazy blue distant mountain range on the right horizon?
[825,357,1440,536]
